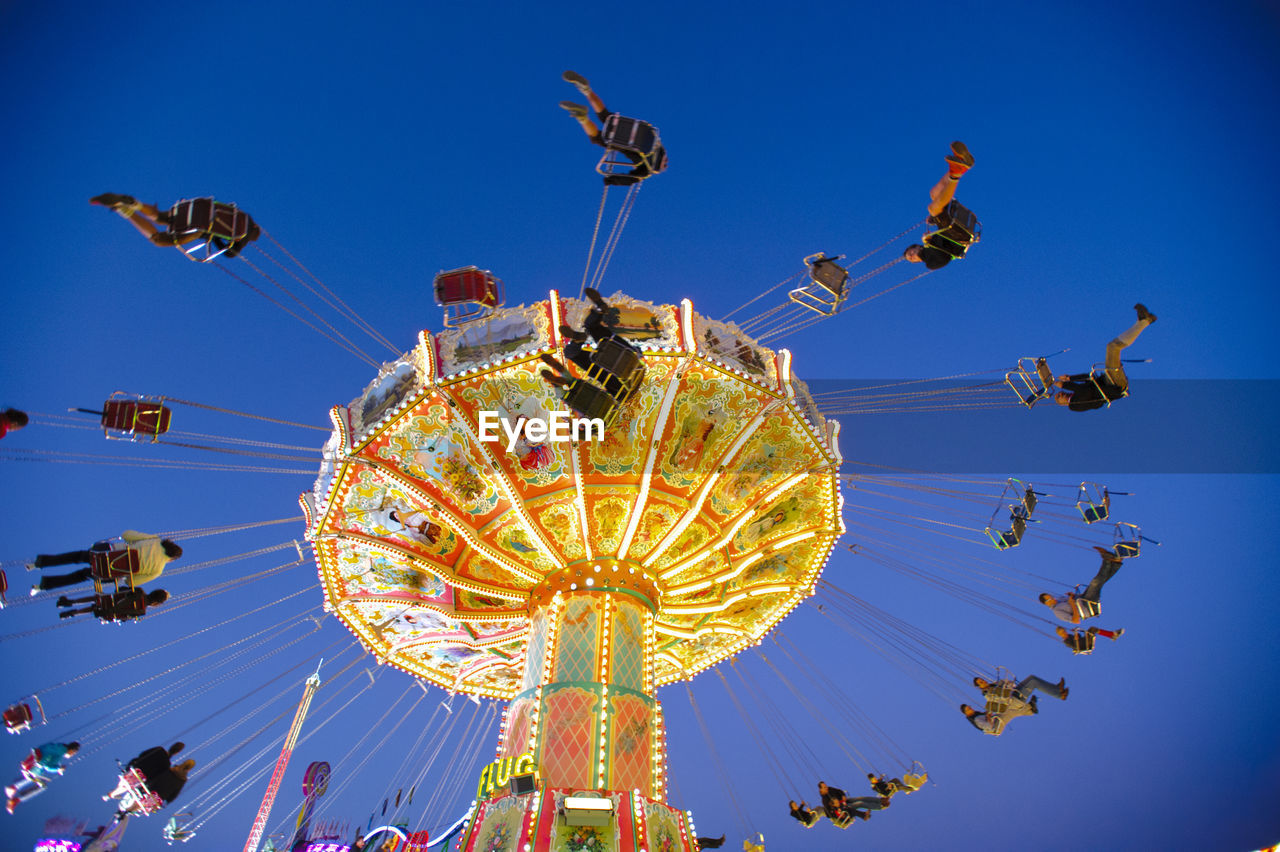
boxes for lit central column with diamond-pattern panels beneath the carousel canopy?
[499,563,666,801]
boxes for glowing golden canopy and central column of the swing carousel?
[303,284,841,849]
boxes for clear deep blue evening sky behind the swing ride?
[0,3,1280,849]
